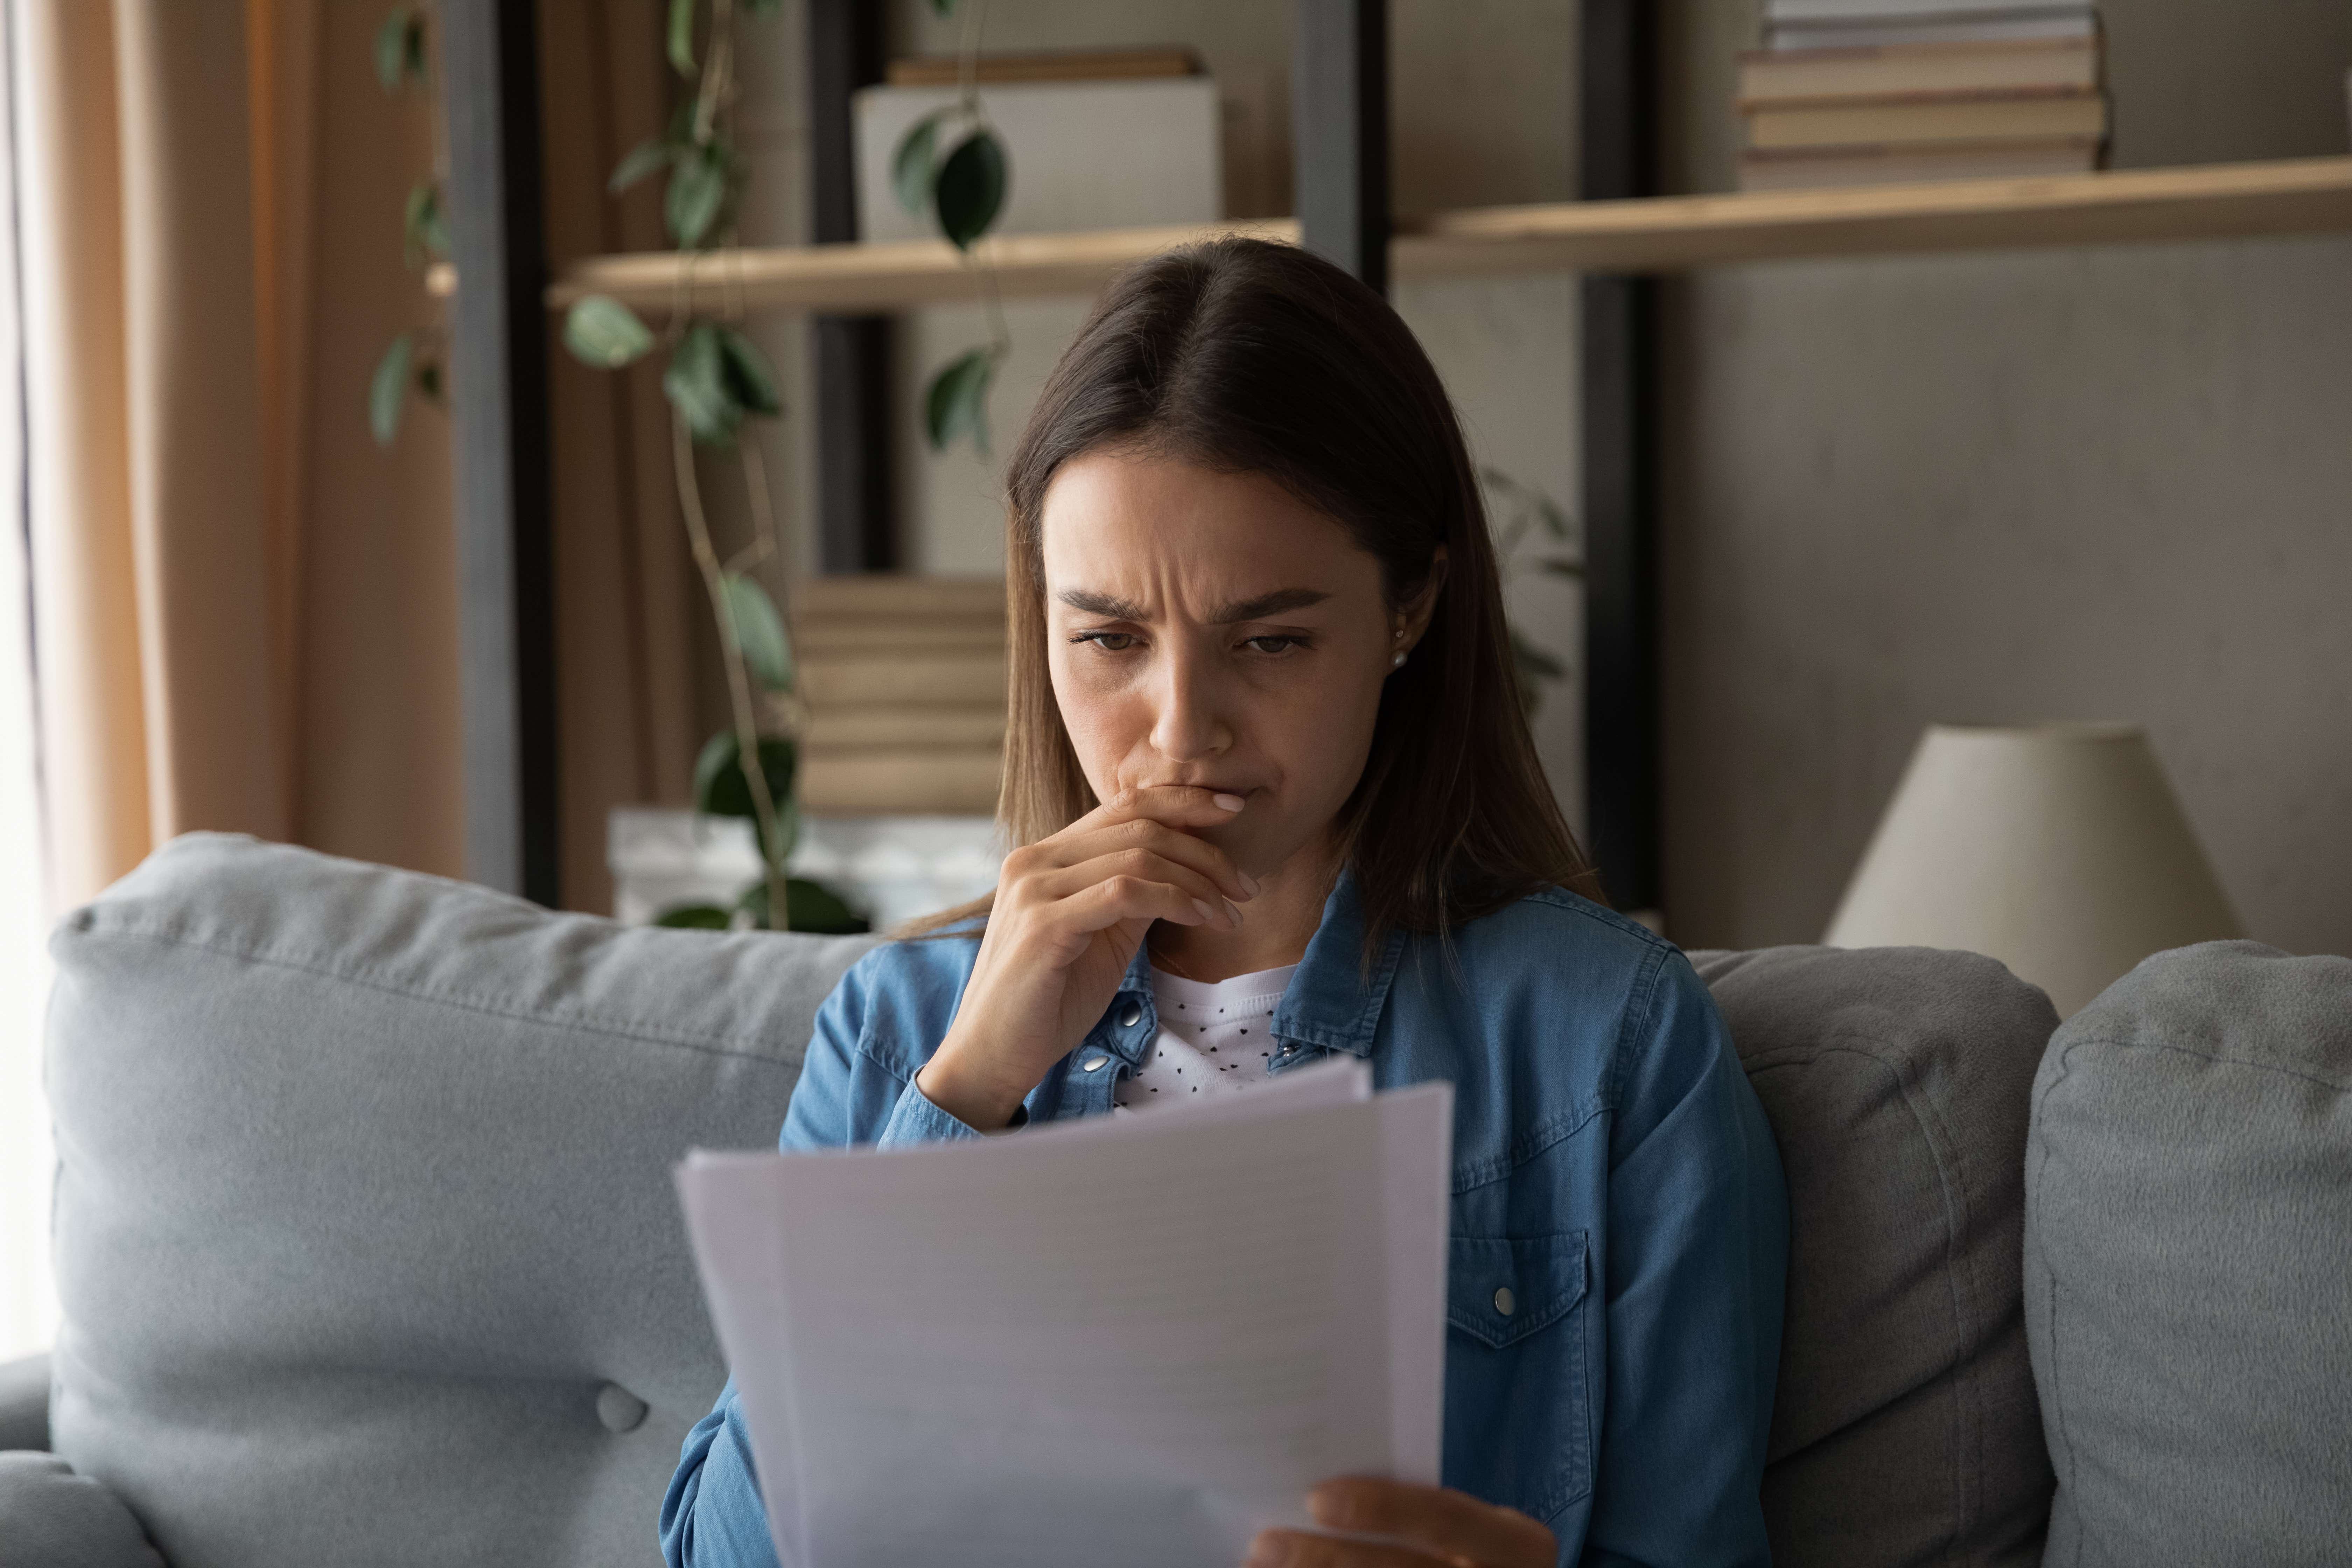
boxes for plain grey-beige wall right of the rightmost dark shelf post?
[1663,0,2352,952]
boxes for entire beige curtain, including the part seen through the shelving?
[18,0,710,910]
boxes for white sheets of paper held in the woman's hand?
[677,1060,1454,1568]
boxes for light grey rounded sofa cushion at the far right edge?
[2025,943,2352,1568]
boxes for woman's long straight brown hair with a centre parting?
[920,237,1602,957]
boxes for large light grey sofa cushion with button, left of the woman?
[49,834,870,1568]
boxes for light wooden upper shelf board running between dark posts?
[430,158,2352,310]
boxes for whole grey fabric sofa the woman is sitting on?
[0,834,2352,1568]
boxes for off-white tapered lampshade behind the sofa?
[1823,724,2239,1018]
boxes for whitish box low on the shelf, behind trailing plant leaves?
[604,806,1004,931]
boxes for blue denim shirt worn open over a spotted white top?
[661,877,1787,1568]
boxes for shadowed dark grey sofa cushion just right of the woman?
[1691,947,2058,1568]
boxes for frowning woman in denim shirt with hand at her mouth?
[661,240,1787,1568]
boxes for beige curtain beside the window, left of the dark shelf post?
[12,0,461,905]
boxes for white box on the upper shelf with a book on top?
[856,75,1225,240]
